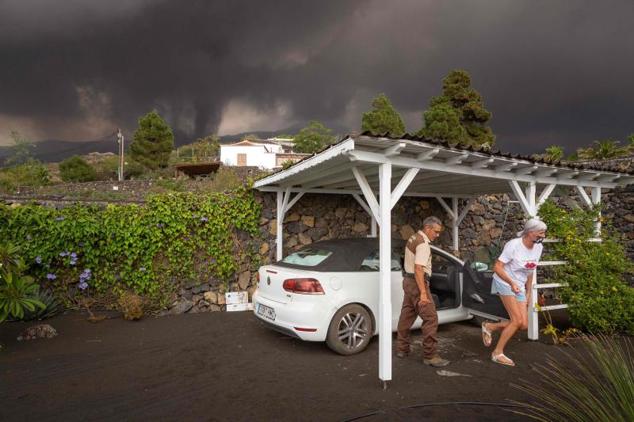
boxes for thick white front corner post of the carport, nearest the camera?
[378,163,392,389]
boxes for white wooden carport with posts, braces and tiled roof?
[254,133,634,386]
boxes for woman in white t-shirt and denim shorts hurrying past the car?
[482,218,546,366]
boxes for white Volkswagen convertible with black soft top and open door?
[253,238,508,355]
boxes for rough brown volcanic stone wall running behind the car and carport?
[5,181,634,313]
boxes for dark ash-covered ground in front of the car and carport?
[0,313,572,421]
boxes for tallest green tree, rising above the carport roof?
[418,70,495,147]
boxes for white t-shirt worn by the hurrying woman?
[493,237,544,290]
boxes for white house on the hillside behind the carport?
[220,138,308,169]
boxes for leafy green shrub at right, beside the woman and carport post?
[540,201,634,333]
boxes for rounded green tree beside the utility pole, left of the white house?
[130,110,174,170]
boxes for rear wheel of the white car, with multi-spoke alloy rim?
[326,305,373,355]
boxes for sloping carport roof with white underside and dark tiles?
[254,133,634,197]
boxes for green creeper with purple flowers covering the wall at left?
[0,189,260,307]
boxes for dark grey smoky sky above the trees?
[0,0,634,153]
